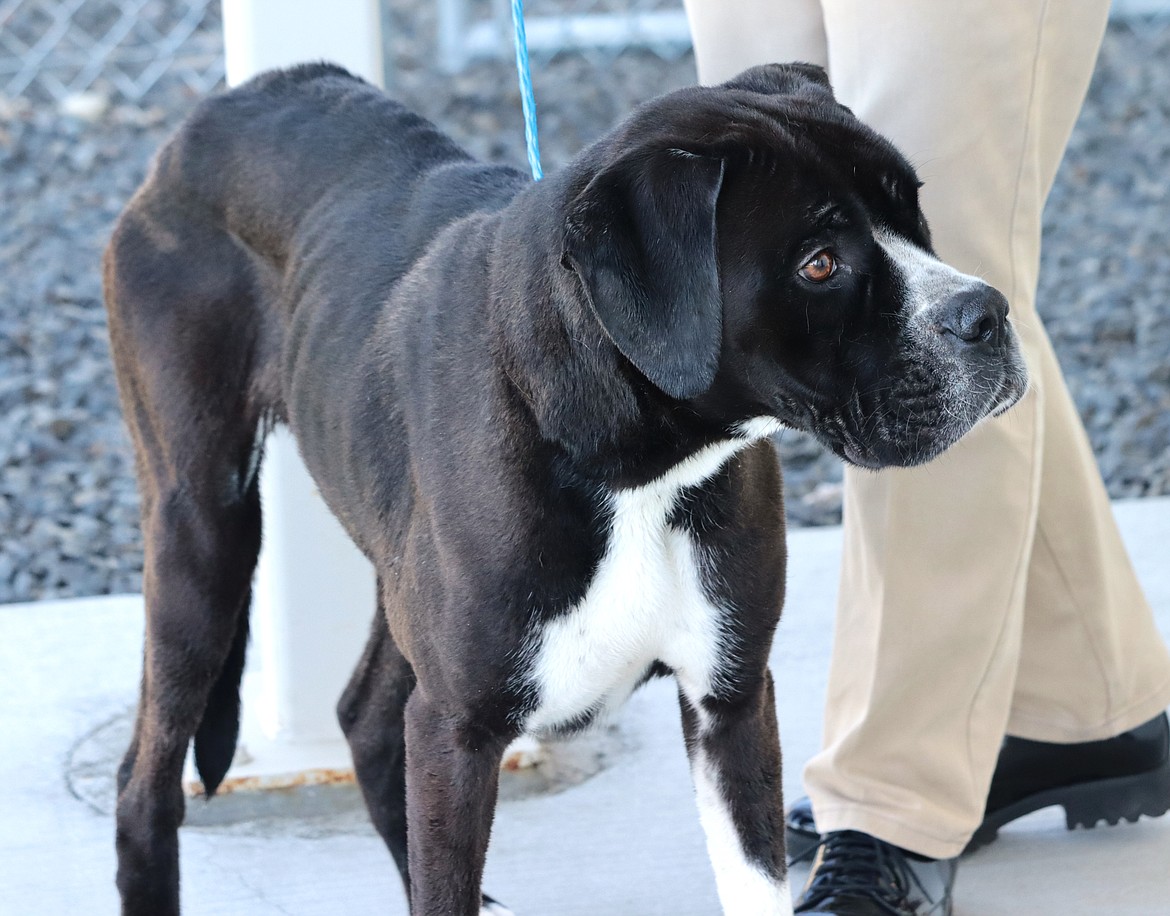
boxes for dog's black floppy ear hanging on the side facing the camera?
[562,150,723,399]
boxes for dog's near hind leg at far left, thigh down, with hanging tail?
[105,212,269,916]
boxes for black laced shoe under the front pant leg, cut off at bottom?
[796,831,956,916]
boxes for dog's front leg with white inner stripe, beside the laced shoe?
[679,670,792,916]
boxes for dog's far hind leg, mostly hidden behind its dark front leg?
[337,603,511,916]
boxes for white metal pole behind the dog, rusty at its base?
[201,0,383,788]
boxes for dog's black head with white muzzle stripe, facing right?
[563,64,1026,467]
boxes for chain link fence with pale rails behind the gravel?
[0,0,1170,102]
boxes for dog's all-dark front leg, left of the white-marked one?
[406,684,511,916]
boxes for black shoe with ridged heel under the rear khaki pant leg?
[785,712,1170,861]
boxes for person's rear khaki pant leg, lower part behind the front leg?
[1007,332,1170,743]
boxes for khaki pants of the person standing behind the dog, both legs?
[805,0,1170,856]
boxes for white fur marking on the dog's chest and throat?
[524,418,778,732]
